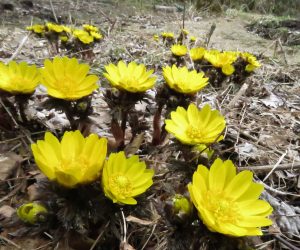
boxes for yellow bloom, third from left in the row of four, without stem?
[103,61,156,93]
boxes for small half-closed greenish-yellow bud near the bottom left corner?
[17,202,48,224]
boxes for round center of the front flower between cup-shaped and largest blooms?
[109,174,132,197]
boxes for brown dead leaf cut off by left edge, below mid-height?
[0,152,23,181]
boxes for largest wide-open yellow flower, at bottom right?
[188,158,273,237]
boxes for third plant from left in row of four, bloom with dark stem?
[104,61,156,148]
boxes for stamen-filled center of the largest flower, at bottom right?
[205,191,239,224]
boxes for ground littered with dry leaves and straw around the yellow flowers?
[0,0,300,249]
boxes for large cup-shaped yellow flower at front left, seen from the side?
[31,130,107,188]
